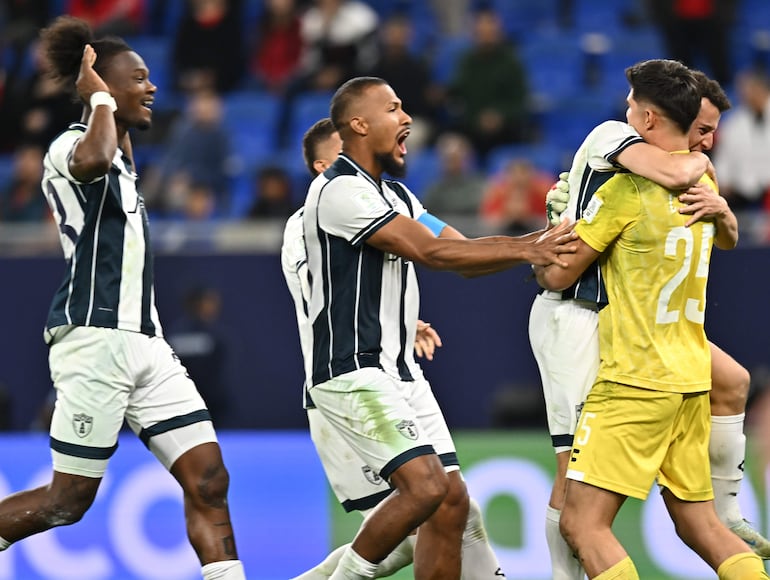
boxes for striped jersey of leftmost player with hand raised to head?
[42,123,162,336]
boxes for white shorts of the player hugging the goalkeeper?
[529,290,599,453]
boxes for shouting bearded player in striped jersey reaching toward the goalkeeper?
[303,77,573,580]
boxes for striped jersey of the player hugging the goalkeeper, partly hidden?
[562,121,643,308]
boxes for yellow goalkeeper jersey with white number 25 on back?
[576,173,716,393]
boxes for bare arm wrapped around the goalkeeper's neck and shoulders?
[617,143,709,189]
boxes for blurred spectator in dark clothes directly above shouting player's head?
[363,12,441,151]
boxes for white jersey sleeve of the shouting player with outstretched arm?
[318,176,398,245]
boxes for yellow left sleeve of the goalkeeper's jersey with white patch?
[575,173,641,252]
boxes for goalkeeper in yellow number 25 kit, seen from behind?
[535,60,767,580]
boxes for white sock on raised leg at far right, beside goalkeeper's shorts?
[709,413,746,527]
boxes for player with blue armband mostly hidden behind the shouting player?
[281,118,504,580]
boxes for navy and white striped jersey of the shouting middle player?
[303,154,425,385]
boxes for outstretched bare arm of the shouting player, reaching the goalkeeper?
[367,215,577,275]
